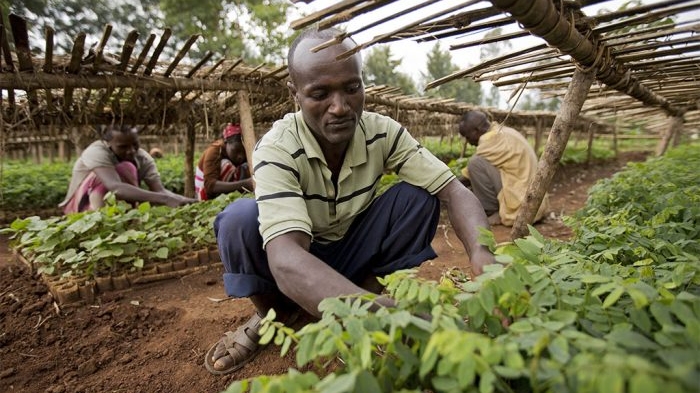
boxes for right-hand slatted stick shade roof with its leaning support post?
[292,0,700,237]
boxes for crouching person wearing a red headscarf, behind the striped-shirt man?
[194,123,253,201]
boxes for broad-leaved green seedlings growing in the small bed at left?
[0,193,247,278]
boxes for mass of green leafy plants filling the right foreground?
[226,145,700,393]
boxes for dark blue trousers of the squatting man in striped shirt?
[214,182,440,297]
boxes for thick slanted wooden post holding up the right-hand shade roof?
[510,69,595,239]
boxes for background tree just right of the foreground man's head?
[364,45,418,94]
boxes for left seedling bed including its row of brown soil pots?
[0,193,241,305]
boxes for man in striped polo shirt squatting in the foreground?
[205,29,494,374]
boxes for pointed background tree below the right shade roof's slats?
[423,42,482,104]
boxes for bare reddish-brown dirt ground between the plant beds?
[0,153,647,393]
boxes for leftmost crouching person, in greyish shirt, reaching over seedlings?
[59,125,197,214]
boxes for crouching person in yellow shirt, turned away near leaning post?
[459,111,549,226]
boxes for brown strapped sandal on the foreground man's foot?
[204,312,263,375]
